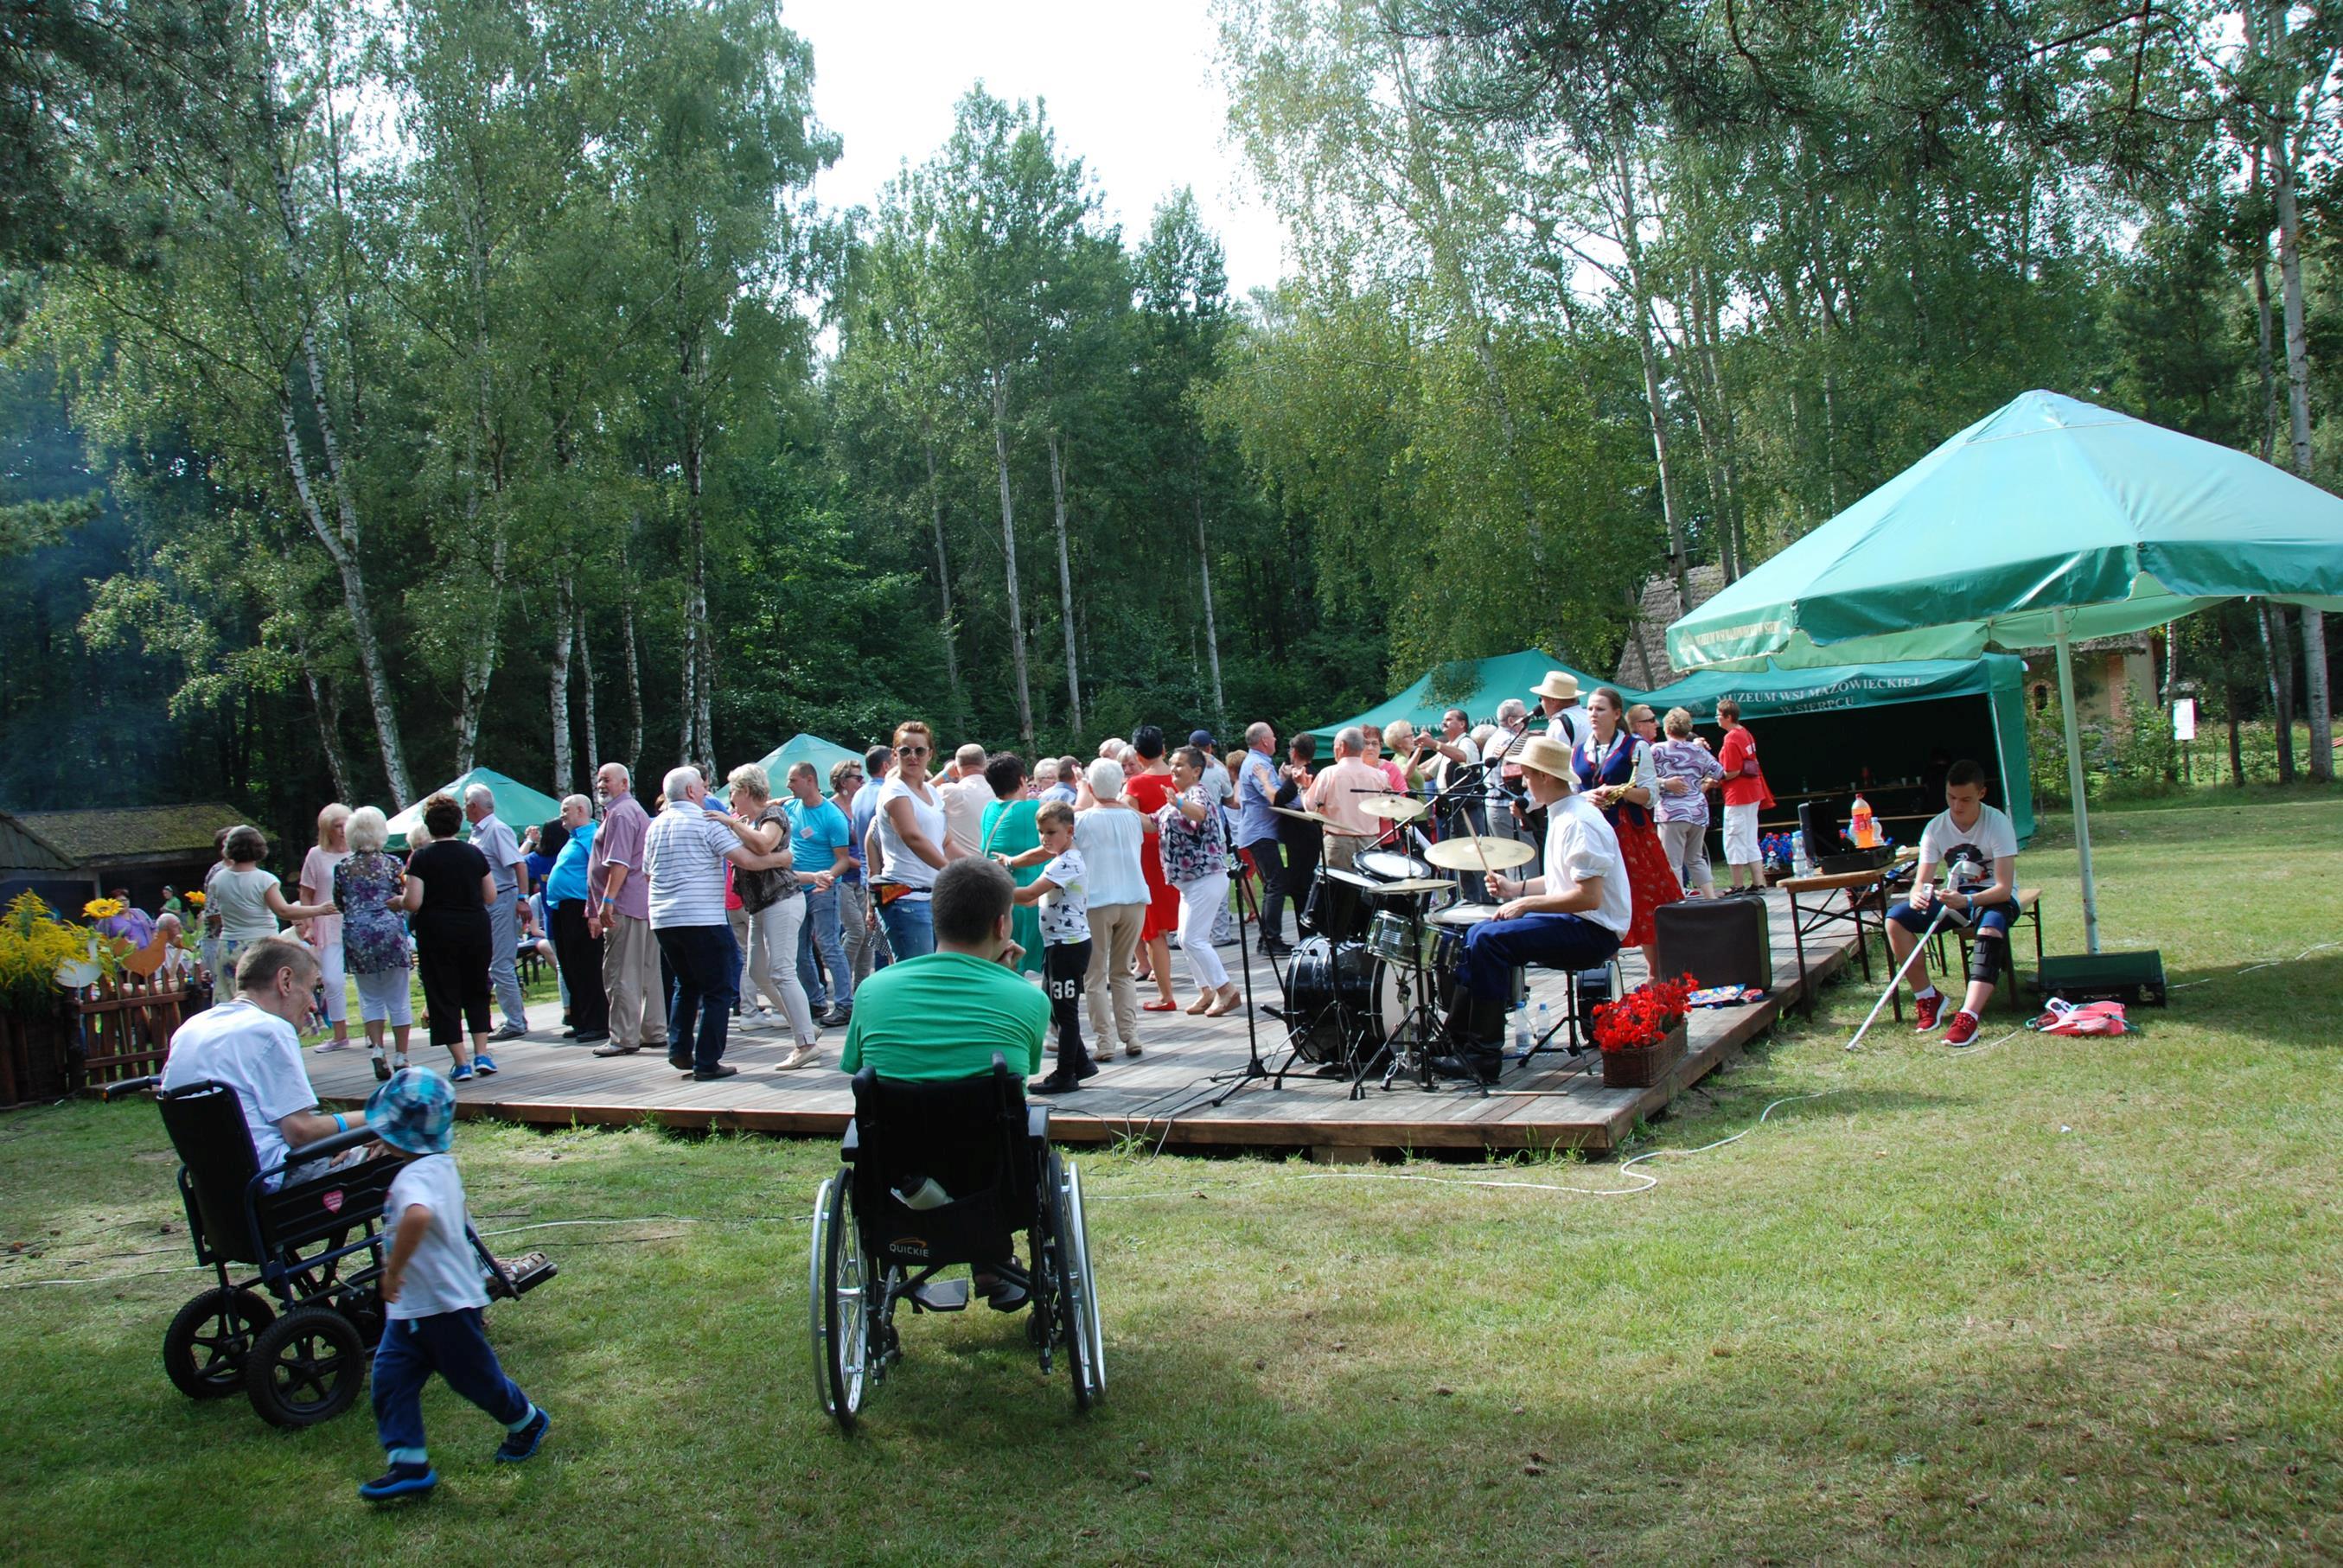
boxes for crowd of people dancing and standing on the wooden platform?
[131,670,1765,1093]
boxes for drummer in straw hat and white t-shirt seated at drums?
[1434,736,1636,1083]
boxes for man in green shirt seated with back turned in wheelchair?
[839,856,1050,1312]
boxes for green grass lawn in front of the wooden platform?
[0,794,2343,1564]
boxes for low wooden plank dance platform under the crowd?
[307,893,1887,1160]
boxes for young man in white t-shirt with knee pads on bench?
[1888,762,2017,1045]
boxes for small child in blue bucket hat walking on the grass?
[359,1067,551,1502]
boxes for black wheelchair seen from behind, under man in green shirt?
[808,1052,1106,1432]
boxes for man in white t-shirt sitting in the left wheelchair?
[162,938,349,1189]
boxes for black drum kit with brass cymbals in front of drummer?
[1280,794,1537,1097]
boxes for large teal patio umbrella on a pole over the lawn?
[1669,392,2343,952]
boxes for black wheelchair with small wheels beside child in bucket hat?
[105,1078,560,1430]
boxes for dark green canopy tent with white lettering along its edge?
[1633,654,2033,853]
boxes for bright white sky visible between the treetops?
[782,0,1281,297]
